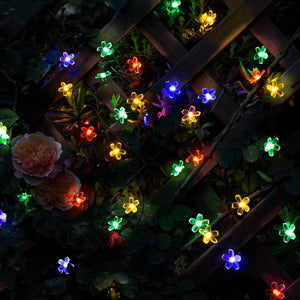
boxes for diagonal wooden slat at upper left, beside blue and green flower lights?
[44,0,160,94]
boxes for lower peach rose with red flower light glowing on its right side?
[31,169,81,211]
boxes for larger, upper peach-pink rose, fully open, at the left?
[11,132,62,185]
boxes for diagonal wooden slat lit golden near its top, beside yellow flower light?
[145,0,272,99]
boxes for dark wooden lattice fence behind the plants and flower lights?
[1,0,300,299]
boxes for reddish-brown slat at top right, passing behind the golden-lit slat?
[223,0,300,69]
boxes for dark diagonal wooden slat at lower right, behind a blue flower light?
[183,189,294,285]
